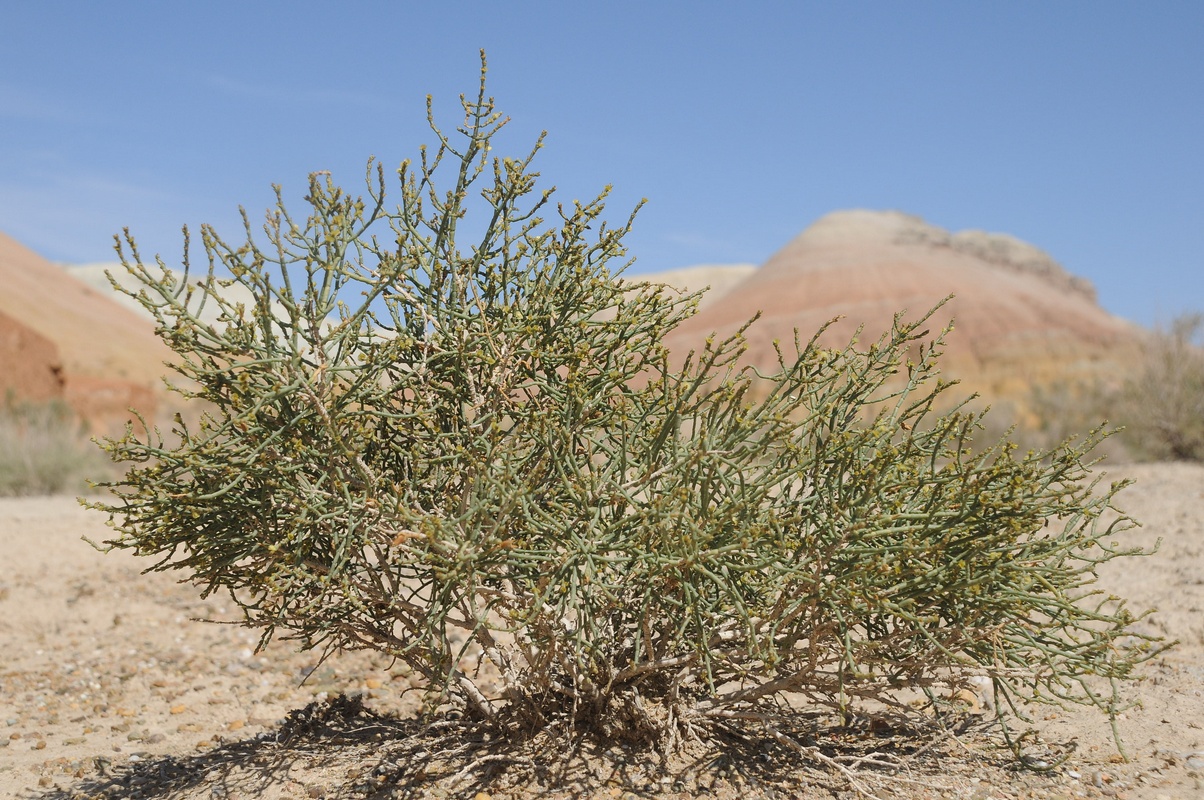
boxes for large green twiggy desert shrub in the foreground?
[95,59,1157,761]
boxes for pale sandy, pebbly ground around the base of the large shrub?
[0,464,1204,800]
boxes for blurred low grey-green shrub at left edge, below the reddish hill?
[0,398,111,496]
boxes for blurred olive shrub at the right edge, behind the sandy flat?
[1115,313,1204,461]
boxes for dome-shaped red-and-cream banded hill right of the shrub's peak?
[668,211,1141,400]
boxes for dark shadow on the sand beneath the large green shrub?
[32,695,1001,800]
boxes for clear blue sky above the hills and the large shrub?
[0,0,1204,324]
